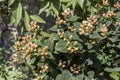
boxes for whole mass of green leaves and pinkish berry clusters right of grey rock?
[0,0,120,80]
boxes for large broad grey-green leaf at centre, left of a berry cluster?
[55,40,67,53]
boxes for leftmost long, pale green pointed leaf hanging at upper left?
[14,2,22,26]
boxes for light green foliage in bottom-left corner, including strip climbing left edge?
[0,48,27,80]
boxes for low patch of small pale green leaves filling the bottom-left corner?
[0,64,27,80]
